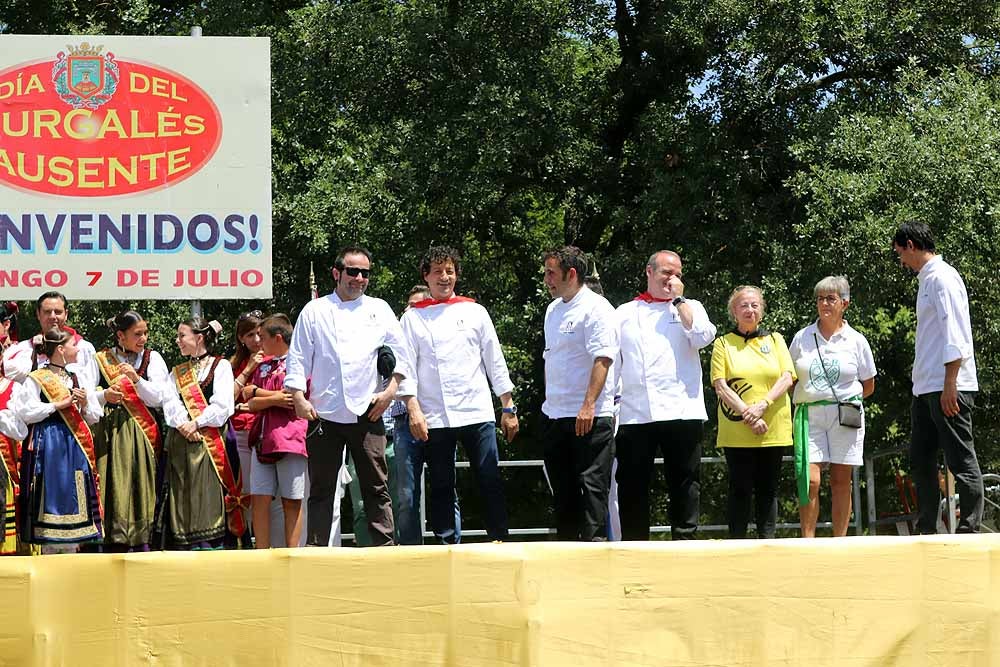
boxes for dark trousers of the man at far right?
[910,391,983,534]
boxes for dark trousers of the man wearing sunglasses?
[306,419,393,547]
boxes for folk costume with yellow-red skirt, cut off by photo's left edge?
[0,376,28,555]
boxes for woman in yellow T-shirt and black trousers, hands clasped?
[712,285,795,538]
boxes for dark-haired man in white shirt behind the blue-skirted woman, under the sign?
[3,292,100,387]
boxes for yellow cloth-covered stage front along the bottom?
[0,536,1000,667]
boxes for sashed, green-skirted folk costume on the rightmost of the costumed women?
[160,356,249,549]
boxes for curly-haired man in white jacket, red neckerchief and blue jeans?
[399,246,518,544]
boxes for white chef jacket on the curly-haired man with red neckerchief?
[399,301,514,428]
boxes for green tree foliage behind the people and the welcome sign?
[0,0,1000,536]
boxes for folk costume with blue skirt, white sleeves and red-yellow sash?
[16,363,103,544]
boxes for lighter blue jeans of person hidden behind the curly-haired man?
[393,414,462,544]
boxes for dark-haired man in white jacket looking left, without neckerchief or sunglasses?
[541,246,618,542]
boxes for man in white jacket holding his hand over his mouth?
[615,250,715,540]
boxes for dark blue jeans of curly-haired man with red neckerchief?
[426,421,507,543]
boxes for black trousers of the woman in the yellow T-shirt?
[725,447,786,538]
